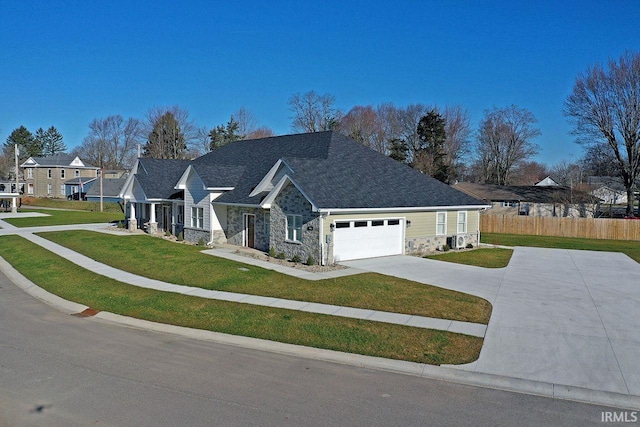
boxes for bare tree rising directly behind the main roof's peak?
[289,90,342,132]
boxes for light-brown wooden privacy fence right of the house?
[480,214,640,240]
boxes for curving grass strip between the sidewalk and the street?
[0,236,482,365]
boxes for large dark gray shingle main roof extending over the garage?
[193,132,483,209]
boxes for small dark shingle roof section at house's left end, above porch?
[136,157,189,200]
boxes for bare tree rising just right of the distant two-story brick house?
[73,114,144,169]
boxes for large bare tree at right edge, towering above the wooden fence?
[564,52,640,216]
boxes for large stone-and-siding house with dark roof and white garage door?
[121,132,488,263]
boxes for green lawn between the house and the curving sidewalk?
[40,231,491,324]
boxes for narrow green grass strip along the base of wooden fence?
[480,233,640,263]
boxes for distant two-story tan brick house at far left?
[20,153,99,198]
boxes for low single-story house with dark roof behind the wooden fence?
[453,182,600,218]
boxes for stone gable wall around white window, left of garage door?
[269,184,321,262]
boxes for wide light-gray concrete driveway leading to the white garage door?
[343,247,640,395]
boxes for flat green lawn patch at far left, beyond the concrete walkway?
[4,208,124,228]
